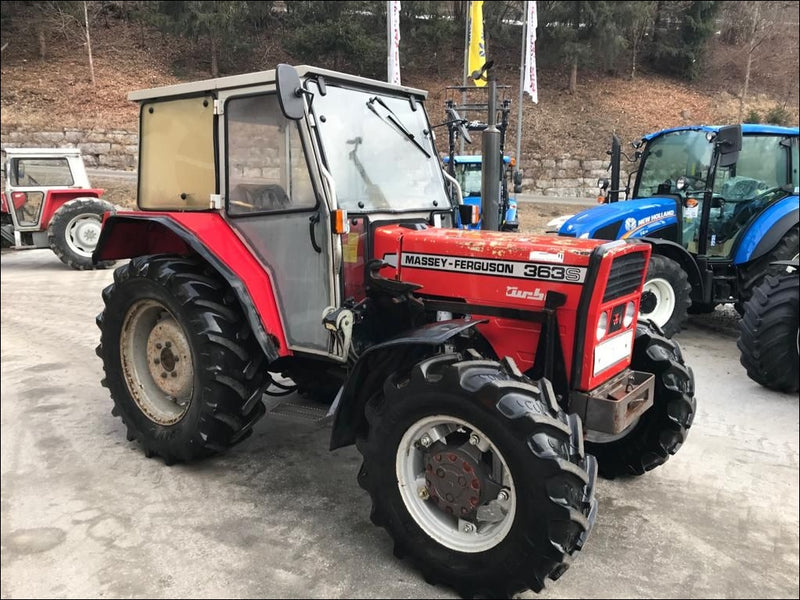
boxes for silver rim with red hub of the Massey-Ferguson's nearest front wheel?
[396,415,517,553]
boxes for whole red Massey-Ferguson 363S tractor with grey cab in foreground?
[94,65,695,597]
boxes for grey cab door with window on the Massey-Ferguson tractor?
[219,88,345,360]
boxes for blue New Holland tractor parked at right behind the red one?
[557,124,800,336]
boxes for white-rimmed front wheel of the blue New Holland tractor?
[639,254,692,337]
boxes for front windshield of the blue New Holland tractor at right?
[634,130,713,198]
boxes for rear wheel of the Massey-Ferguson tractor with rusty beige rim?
[97,256,266,464]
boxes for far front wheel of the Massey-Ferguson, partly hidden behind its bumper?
[586,323,696,478]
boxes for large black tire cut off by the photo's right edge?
[736,271,800,392]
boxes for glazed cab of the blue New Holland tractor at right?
[633,125,798,260]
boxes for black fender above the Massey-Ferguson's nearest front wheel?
[330,319,486,450]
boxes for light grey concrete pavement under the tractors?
[0,250,800,598]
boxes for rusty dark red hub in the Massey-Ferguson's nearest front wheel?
[425,442,489,519]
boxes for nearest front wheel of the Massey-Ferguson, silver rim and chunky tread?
[357,354,597,598]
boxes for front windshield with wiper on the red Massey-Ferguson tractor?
[308,81,449,212]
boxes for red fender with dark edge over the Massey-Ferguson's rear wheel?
[92,212,292,362]
